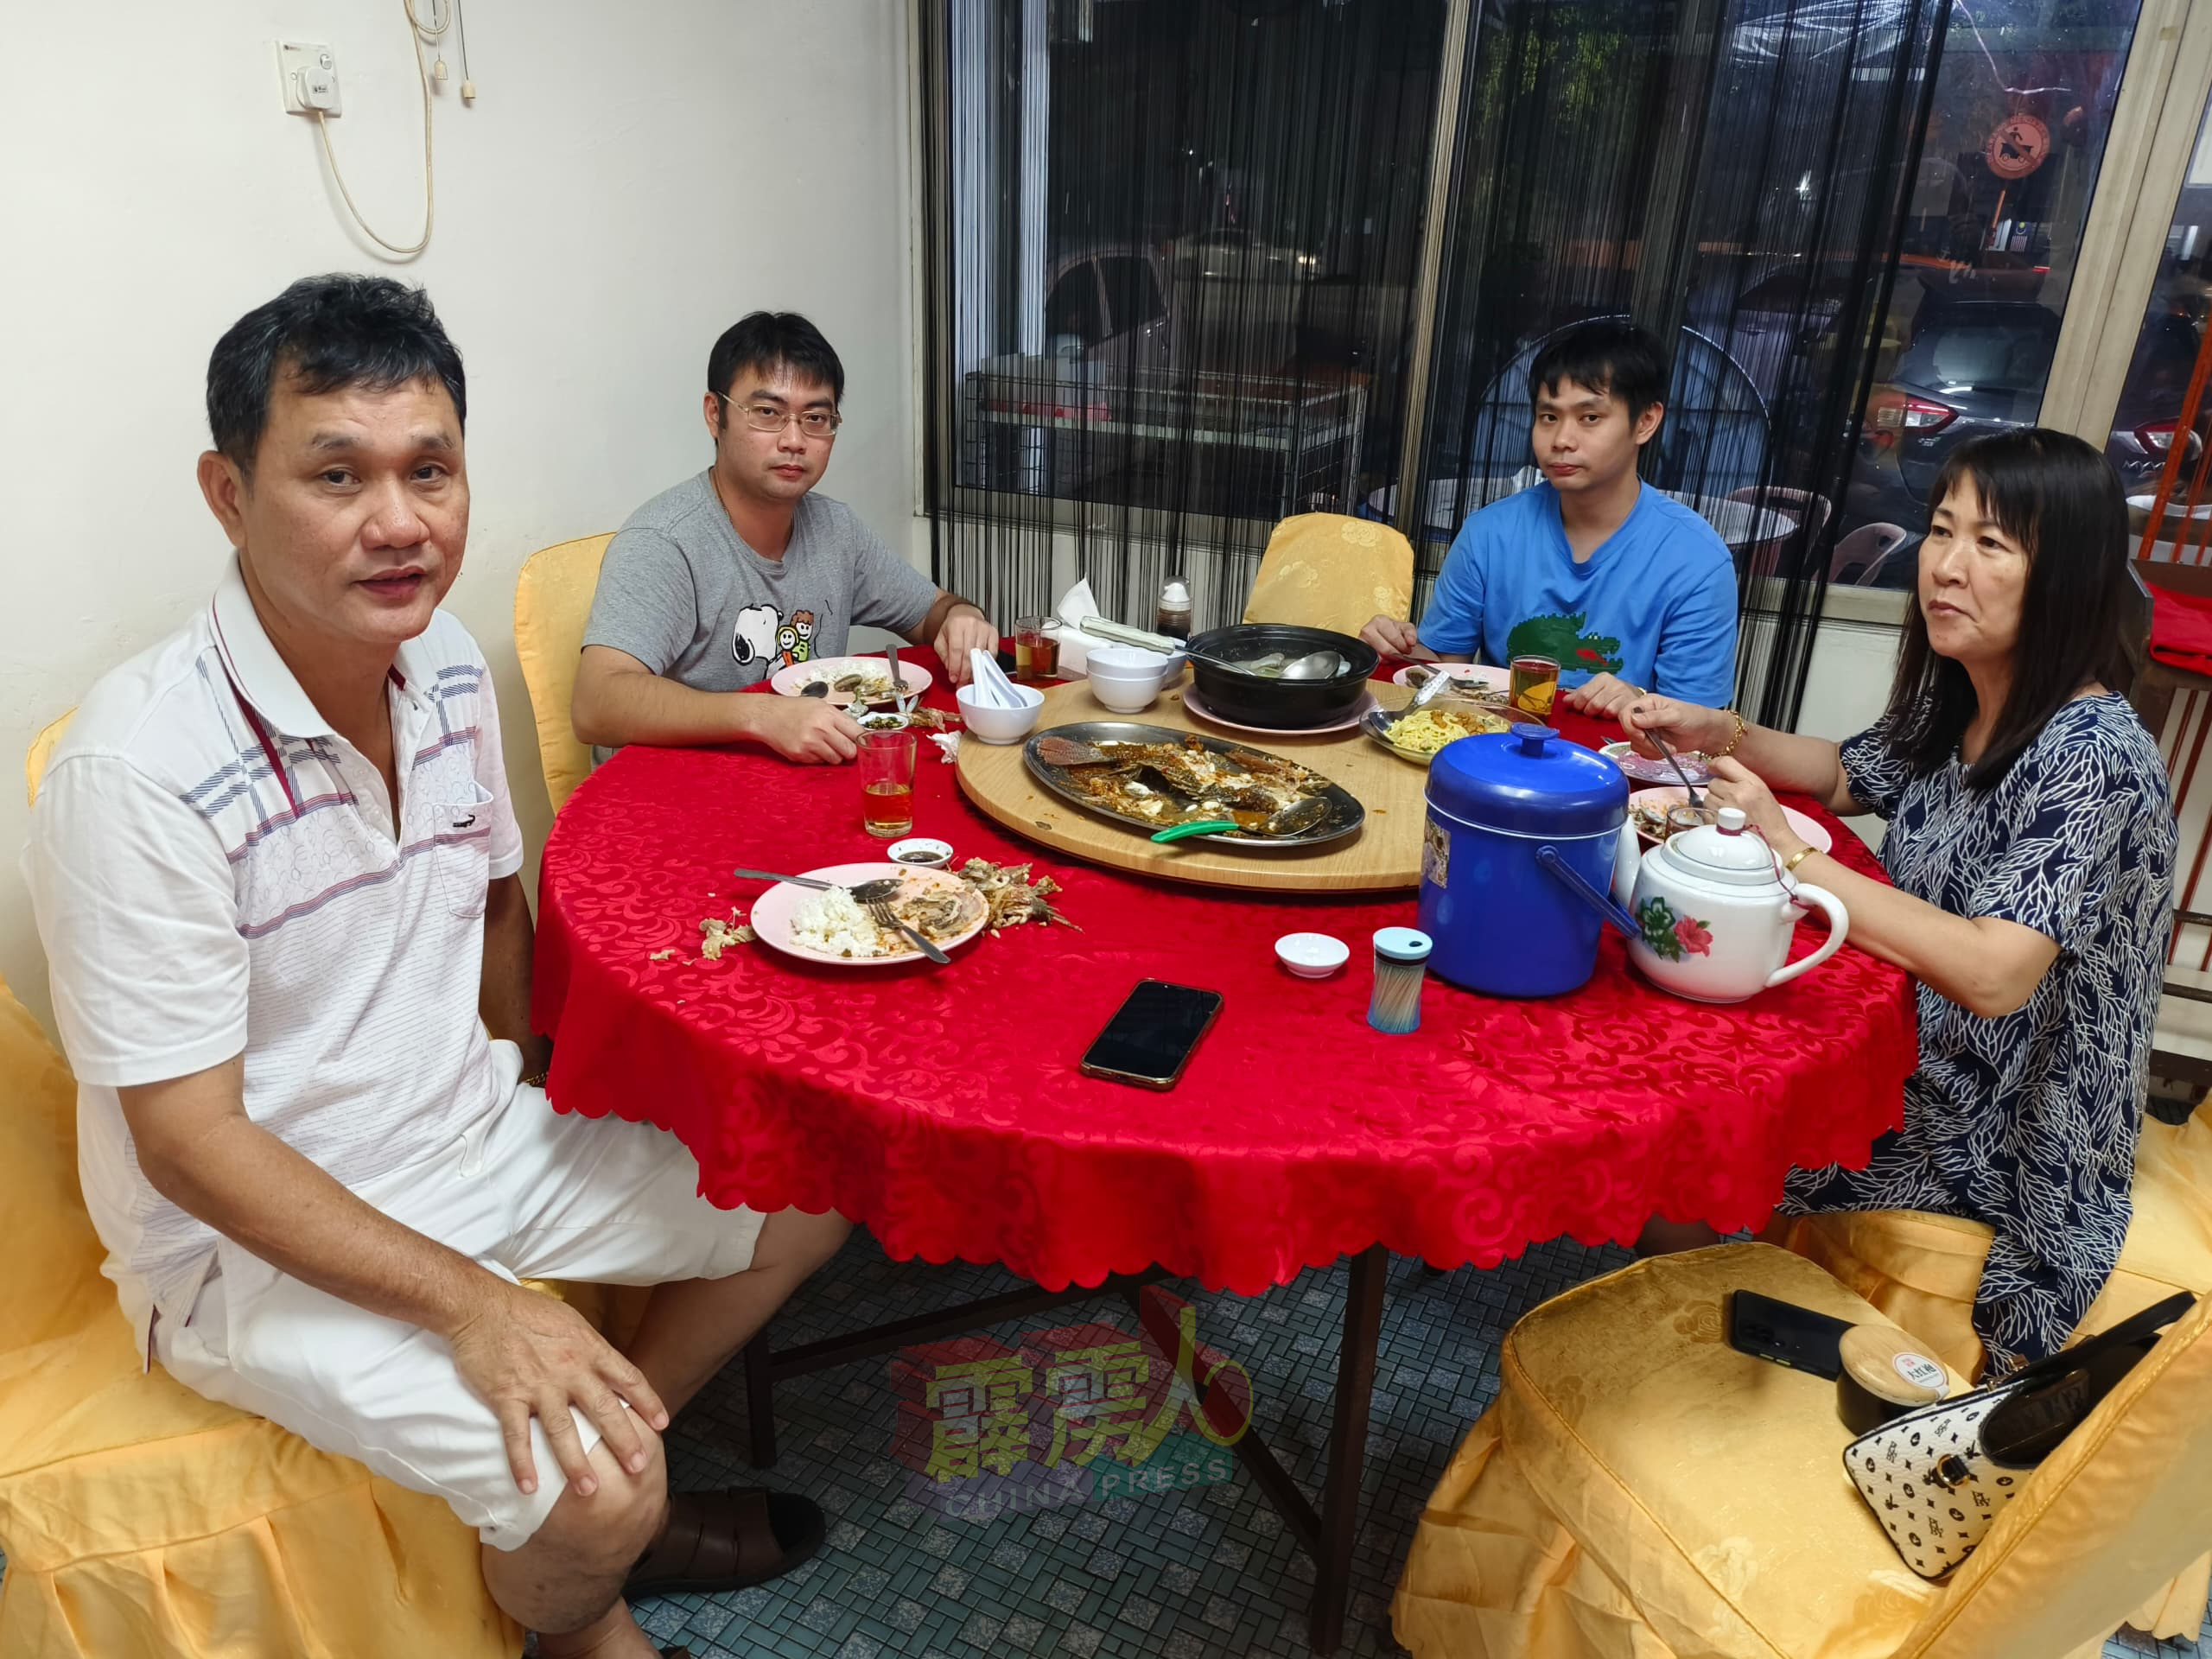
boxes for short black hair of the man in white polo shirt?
[208,272,469,478]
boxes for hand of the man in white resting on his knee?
[449,1274,668,1497]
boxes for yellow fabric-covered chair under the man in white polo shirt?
[0,960,522,1659]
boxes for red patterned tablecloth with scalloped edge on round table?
[536,657,1916,1292]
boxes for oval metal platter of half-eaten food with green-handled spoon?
[1022,721,1367,852]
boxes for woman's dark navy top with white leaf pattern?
[1783,692,2177,1376]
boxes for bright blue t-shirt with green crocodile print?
[1421,485,1737,708]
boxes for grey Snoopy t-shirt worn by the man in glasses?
[584,474,938,761]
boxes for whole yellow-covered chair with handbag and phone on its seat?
[1391,1243,2212,1659]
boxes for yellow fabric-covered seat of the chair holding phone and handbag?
[1391,1245,1964,1659]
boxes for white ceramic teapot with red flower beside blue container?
[1628,807,1852,1002]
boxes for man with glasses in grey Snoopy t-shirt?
[569,312,998,761]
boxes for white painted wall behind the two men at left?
[0,0,927,1035]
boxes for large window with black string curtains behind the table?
[925,0,1947,719]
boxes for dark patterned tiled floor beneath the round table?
[639,1234,2212,1659]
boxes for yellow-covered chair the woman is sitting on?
[1778,1113,2212,1642]
